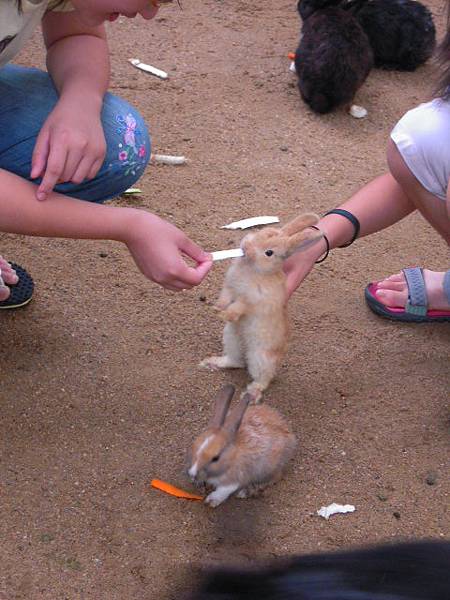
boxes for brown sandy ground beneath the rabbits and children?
[0,0,450,600]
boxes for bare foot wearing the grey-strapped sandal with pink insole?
[374,269,450,311]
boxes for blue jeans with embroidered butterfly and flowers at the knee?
[0,65,151,202]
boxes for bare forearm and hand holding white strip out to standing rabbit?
[0,169,212,291]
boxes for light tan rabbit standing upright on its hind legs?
[200,213,322,402]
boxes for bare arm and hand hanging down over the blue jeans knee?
[31,12,109,200]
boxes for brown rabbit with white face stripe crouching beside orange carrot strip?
[188,384,297,507]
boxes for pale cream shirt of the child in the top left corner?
[0,0,72,67]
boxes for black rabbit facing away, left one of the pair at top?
[295,0,373,113]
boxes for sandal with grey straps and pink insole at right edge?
[364,267,450,323]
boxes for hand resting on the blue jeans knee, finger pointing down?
[31,100,106,200]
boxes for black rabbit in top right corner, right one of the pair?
[341,0,436,71]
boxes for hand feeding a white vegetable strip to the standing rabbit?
[125,210,212,292]
